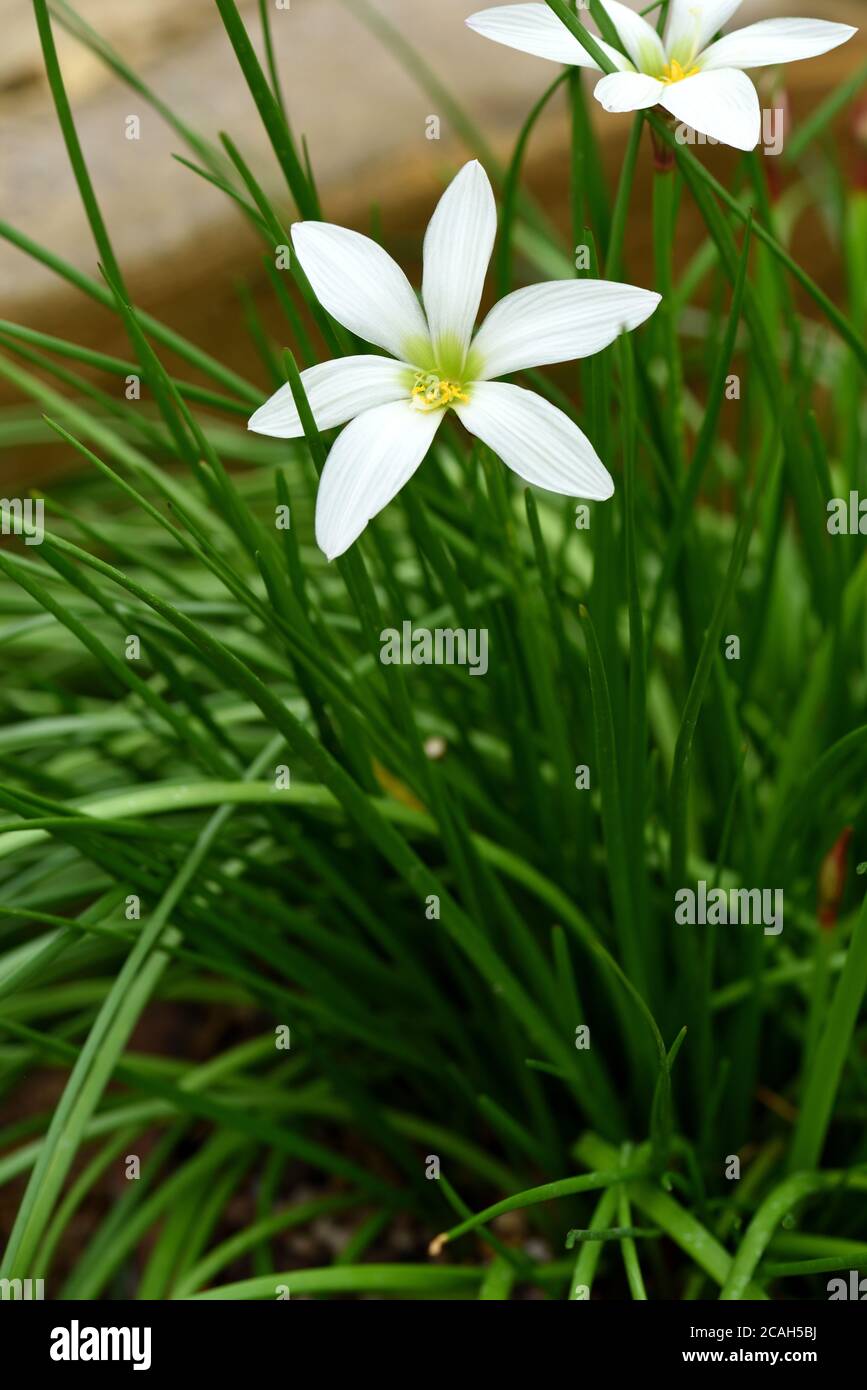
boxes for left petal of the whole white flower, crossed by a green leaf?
[247,357,413,439]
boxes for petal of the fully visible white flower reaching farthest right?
[472,279,660,381]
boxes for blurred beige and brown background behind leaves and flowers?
[0,0,867,481]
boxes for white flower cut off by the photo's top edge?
[467,0,857,150]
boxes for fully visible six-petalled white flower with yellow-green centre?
[250,161,660,560]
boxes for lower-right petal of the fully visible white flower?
[454,381,614,500]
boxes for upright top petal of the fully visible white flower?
[421,160,496,375]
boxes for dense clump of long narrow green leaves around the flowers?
[0,0,867,1298]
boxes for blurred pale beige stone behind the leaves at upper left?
[0,0,863,309]
